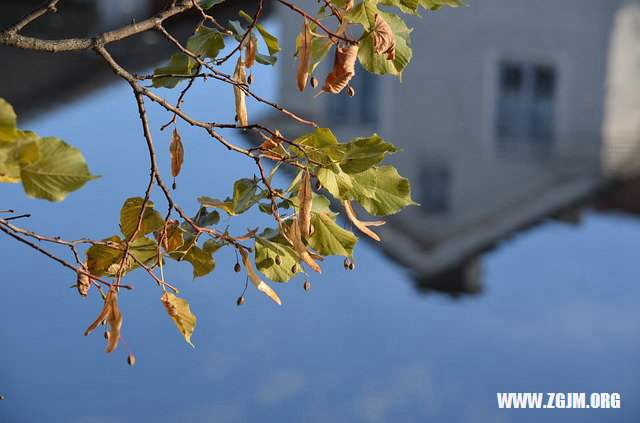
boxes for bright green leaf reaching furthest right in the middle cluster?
[352,166,418,216]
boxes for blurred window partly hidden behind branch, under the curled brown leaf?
[327,65,380,125]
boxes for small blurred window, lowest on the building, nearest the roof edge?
[419,162,451,213]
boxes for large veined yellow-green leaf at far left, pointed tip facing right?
[20,138,98,201]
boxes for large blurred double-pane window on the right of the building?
[495,62,557,153]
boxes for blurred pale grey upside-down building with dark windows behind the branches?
[271,0,640,292]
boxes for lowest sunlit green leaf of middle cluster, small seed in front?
[255,236,300,282]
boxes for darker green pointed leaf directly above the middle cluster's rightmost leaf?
[340,134,401,173]
